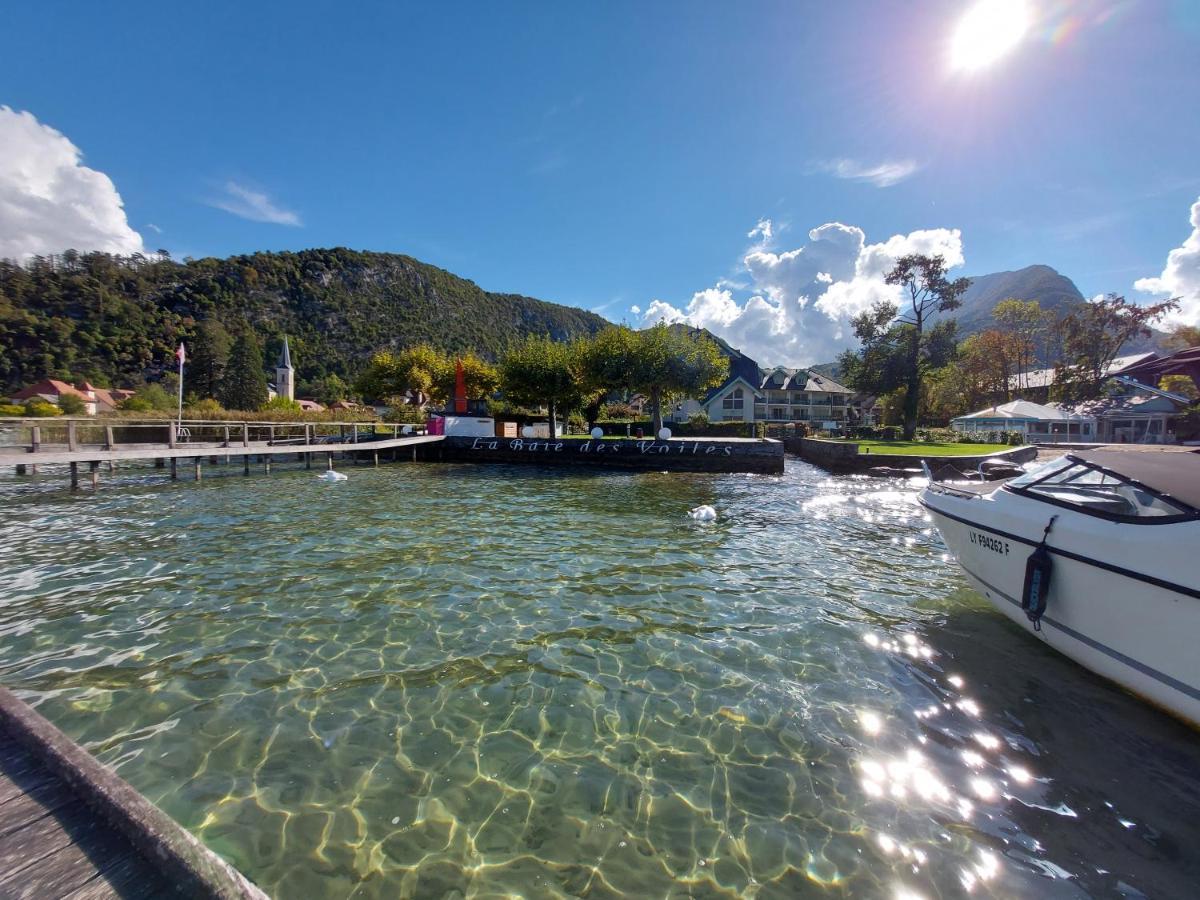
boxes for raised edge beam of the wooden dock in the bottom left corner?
[0,685,268,900]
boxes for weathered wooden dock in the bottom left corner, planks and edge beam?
[0,688,266,900]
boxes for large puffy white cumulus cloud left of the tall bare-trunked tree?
[642,222,962,366]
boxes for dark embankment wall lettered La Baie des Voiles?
[418,437,784,475]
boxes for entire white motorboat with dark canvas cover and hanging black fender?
[920,449,1200,725]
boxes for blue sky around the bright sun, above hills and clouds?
[0,0,1200,361]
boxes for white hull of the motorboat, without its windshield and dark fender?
[920,490,1200,726]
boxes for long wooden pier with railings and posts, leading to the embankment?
[0,419,443,487]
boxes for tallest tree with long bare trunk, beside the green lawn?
[884,253,971,440]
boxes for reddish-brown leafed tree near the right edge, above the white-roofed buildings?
[1055,294,1180,400]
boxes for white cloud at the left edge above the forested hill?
[0,106,142,259]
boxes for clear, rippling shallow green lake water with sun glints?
[0,462,1200,898]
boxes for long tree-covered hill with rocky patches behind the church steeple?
[0,247,608,389]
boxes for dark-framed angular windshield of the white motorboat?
[1006,456,1192,518]
